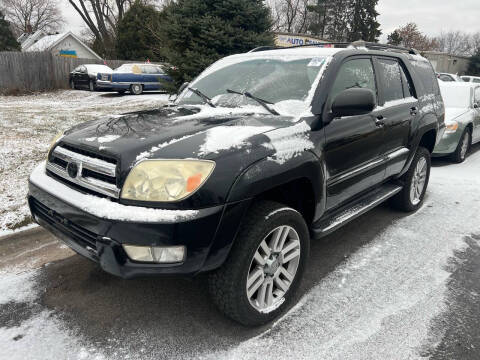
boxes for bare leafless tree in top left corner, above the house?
[3,0,64,35]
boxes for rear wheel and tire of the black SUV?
[391,146,431,212]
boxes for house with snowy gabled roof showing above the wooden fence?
[18,31,102,60]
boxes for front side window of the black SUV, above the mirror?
[330,59,377,101]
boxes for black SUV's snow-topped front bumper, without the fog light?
[28,165,249,278]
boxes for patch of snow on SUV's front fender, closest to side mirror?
[263,121,314,164]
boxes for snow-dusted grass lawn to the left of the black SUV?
[0,90,168,231]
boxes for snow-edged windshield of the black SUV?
[178,56,326,107]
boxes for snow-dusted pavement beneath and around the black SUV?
[0,147,480,360]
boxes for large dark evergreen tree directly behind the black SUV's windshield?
[154,0,273,91]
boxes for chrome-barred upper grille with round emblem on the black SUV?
[47,144,120,198]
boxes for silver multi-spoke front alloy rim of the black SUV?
[246,225,300,313]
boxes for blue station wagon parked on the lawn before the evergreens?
[97,64,171,95]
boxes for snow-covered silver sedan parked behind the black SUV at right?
[433,82,480,163]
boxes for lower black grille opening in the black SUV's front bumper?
[30,198,97,250]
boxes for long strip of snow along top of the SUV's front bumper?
[30,162,198,223]
